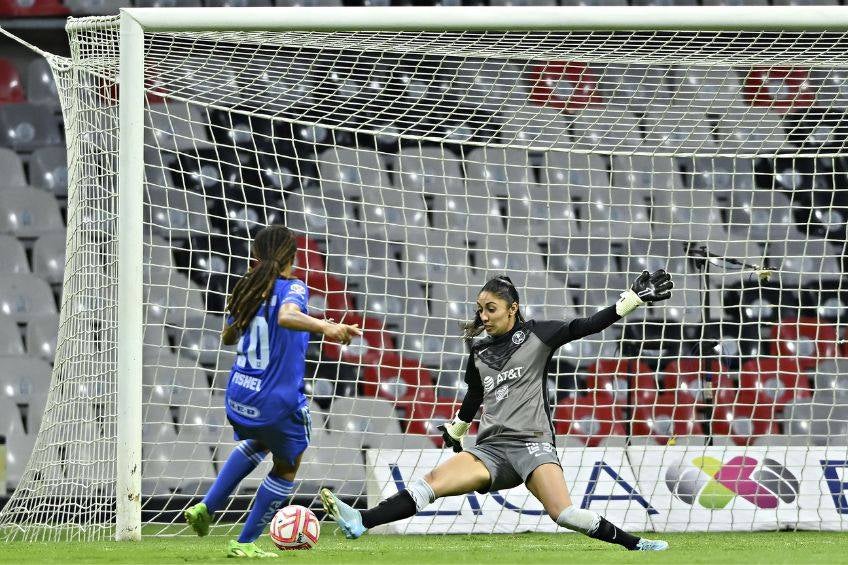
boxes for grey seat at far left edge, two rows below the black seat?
[0,188,64,239]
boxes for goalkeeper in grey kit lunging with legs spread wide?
[321,270,673,551]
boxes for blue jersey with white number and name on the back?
[227,278,309,427]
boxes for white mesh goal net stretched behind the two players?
[0,5,848,539]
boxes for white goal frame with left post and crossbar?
[107,6,848,541]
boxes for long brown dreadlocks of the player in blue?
[221,225,297,345]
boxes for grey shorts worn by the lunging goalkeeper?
[465,436,562,494]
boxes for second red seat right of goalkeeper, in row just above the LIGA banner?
[632,391,703,444]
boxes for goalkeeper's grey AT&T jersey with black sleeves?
[459,306,621,443]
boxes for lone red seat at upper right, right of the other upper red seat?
[742,67,816,113]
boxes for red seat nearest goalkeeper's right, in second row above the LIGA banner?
[586,359,657,405]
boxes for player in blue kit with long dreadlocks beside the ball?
[185,226,362,557]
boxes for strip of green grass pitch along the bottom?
[0,523,848,565]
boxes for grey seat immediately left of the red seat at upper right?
[674,66,744,109]
